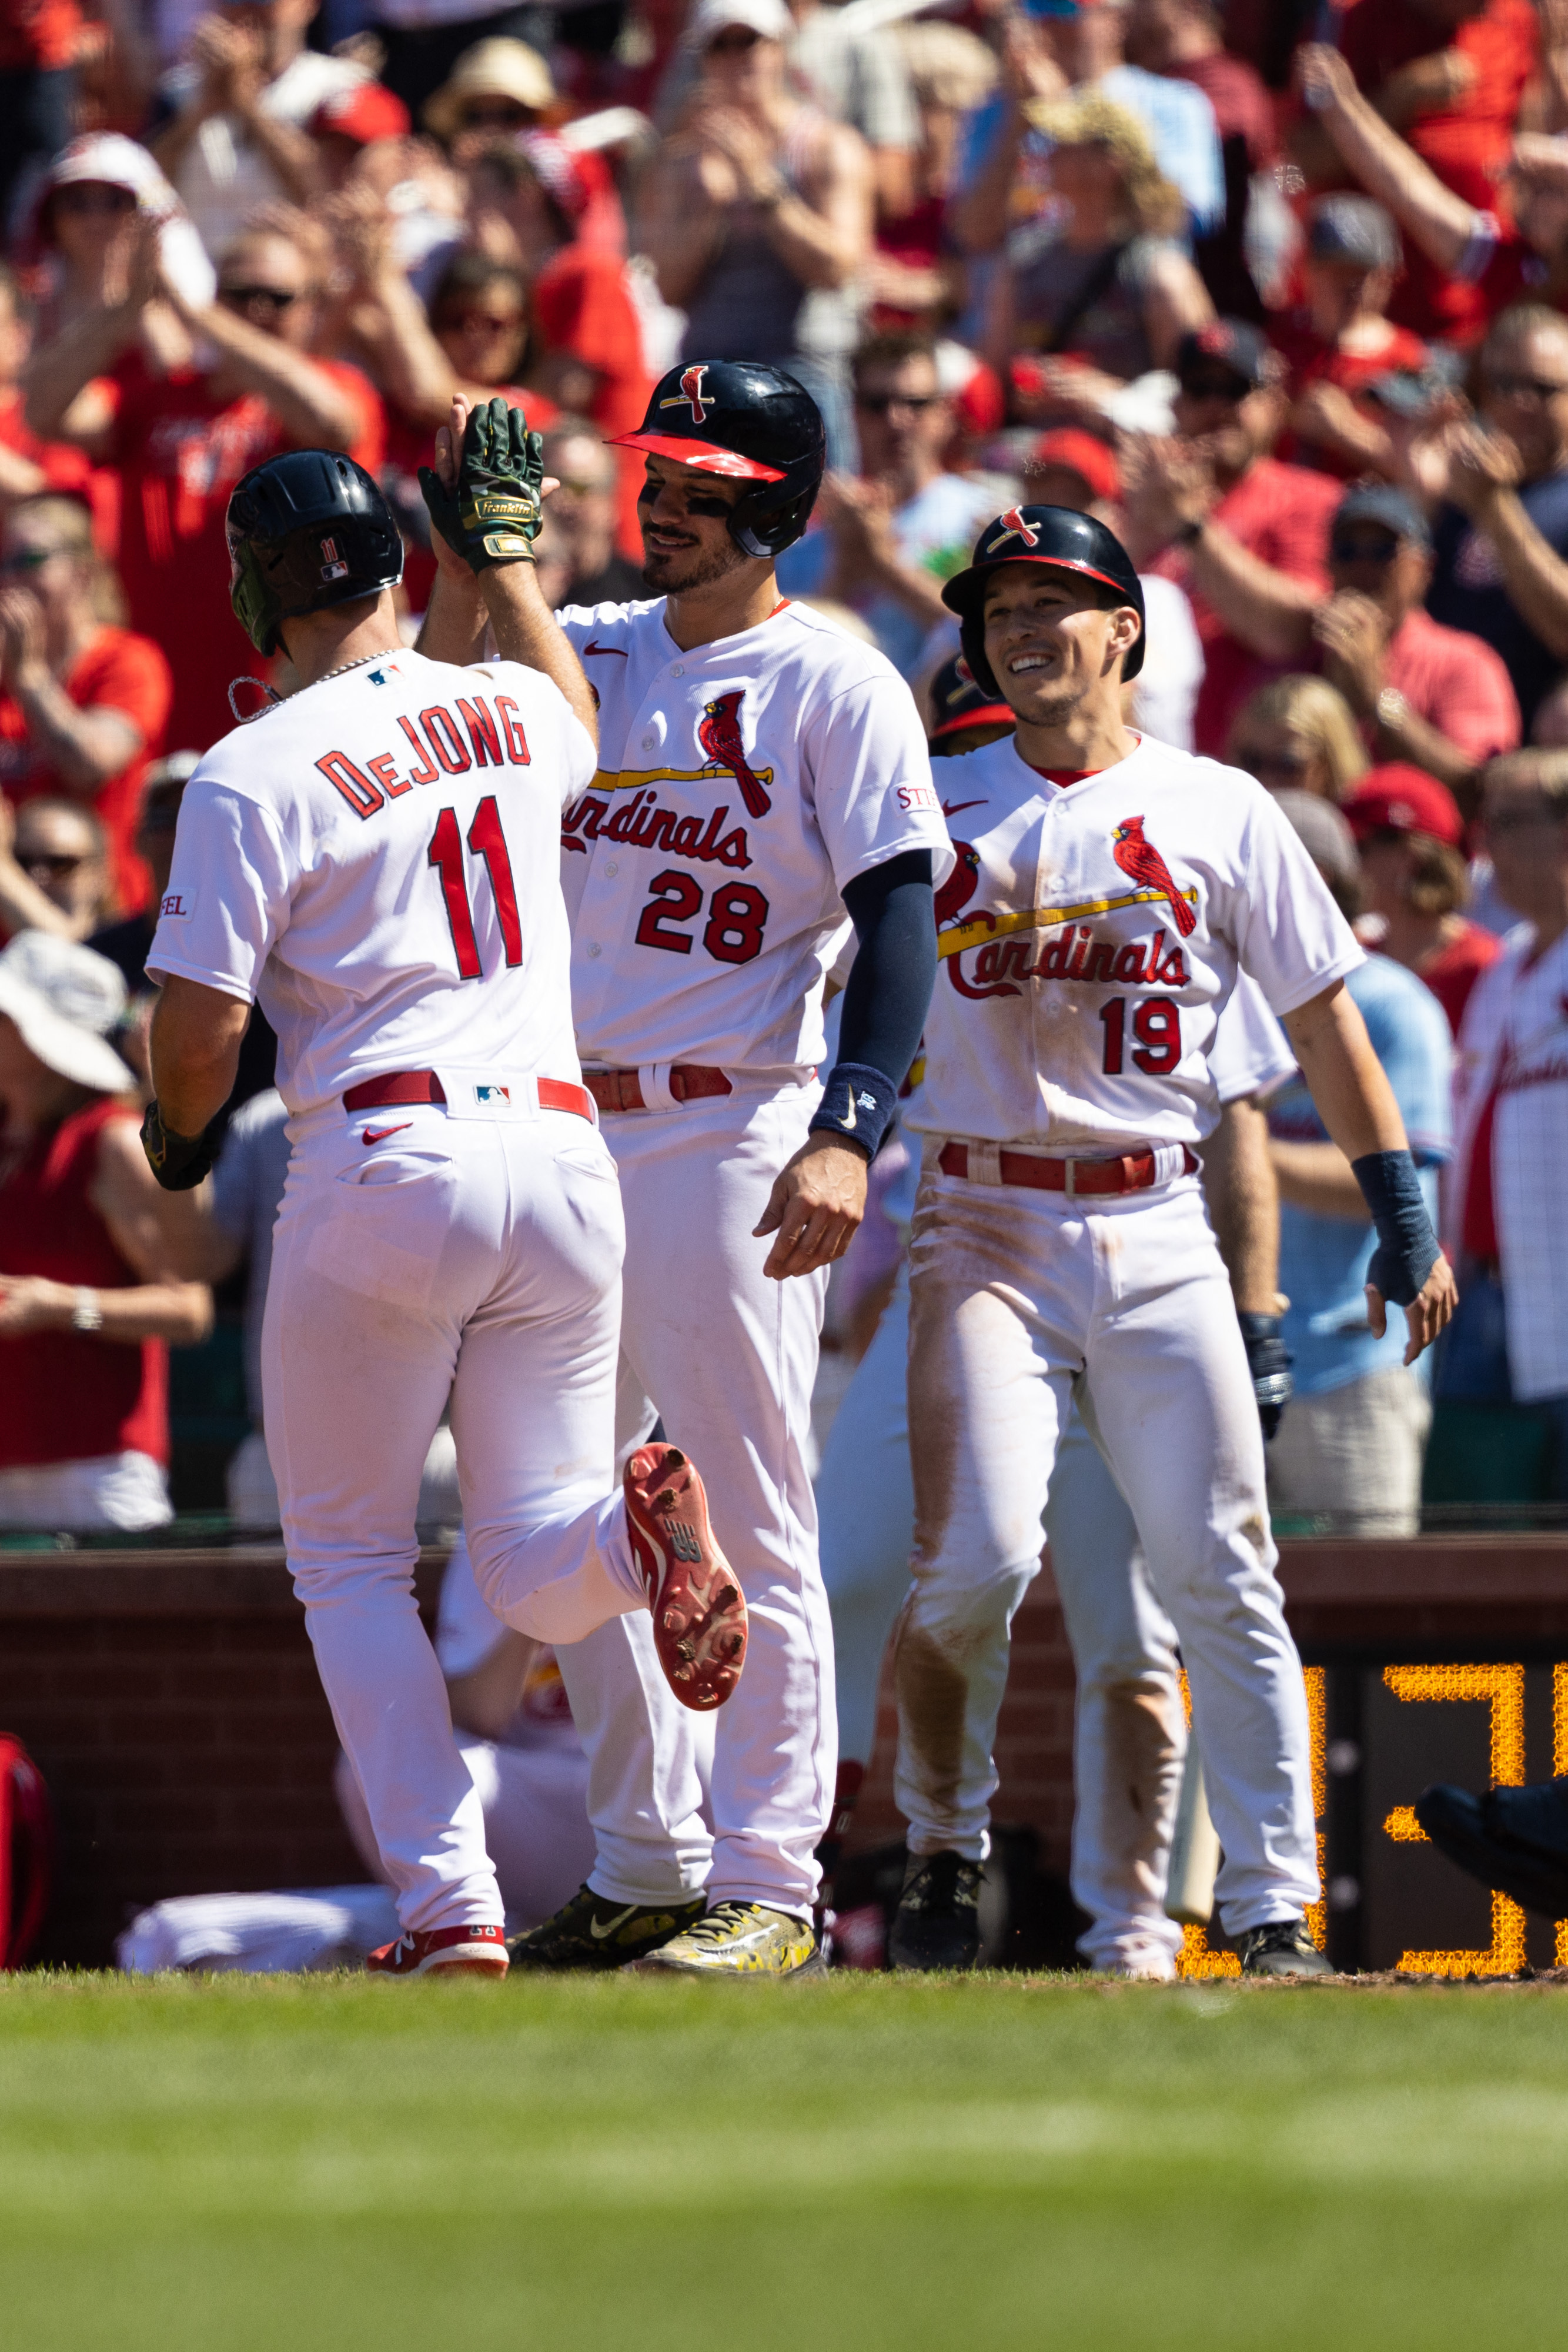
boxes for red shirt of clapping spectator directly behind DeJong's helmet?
[103,350,386,750]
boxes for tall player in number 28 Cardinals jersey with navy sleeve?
[433,362,952,1976]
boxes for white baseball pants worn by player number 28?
[557,1087,837,1915]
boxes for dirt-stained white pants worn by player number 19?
[895,1167,1319,1936]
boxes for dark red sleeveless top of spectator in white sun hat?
[0,1098,169,1470]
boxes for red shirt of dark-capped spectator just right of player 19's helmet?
[1149,456,1342,760]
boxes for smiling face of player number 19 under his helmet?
[985,564,1138,727]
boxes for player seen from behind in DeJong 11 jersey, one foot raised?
[143,402,745,1976]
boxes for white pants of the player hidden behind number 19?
[815,1265,1187,1973]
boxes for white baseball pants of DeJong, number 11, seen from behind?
[261,1101,647,1929]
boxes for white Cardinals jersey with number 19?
[910,736,1363,1152]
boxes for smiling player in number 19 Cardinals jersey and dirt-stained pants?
[893,506,1455,1976]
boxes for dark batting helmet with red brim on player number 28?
[616,360,825,555]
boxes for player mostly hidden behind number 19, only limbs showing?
[815,659,1295,1978]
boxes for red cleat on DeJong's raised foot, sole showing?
[621,1446,745,1712]
